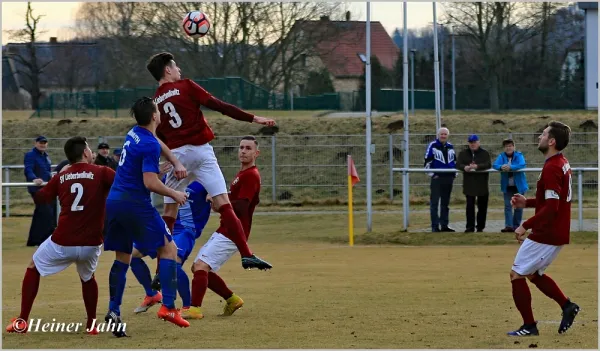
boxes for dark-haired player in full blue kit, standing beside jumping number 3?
[104,97,190,337]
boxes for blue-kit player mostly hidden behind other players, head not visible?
[131,182,211,313]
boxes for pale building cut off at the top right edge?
[578,2,598,110]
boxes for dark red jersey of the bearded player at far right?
[523,153,573,246]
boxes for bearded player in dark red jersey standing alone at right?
[508,122,579,336]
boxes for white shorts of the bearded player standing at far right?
[512,239,562,276]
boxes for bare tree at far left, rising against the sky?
[7,2,52,109]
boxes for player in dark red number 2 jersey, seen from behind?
[6,137,115,335]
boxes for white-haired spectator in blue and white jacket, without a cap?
[425,128,456,233]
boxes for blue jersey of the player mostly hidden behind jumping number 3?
[173,182,211,239]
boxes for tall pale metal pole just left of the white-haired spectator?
[402,1,415,230]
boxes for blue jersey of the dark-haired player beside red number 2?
[108,126,161,204]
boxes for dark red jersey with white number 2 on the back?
[35,163,115,246]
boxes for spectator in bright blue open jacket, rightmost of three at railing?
[493,139,529,233]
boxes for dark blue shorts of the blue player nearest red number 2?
[104,200,173,254]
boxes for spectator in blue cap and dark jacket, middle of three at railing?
[456,134,492,233]
